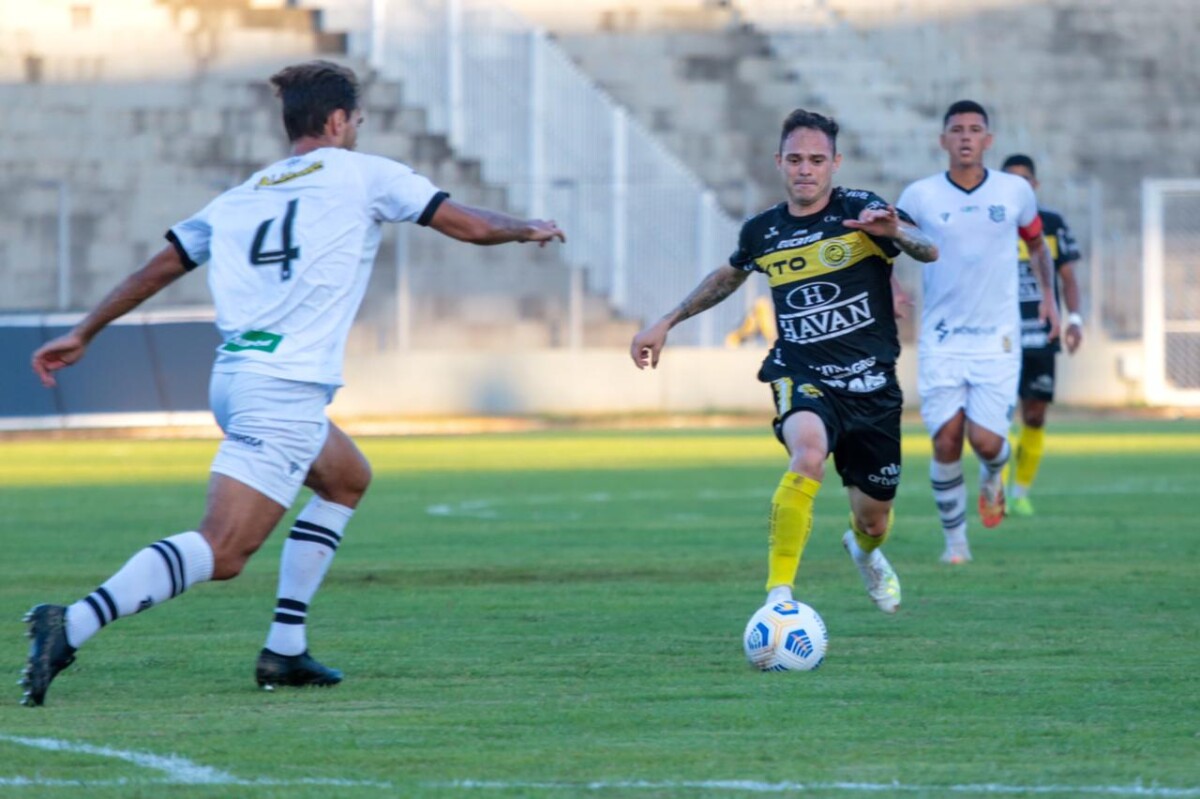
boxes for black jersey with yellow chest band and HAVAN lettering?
[730,187,912,394]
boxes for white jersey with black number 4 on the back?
[167,148,448,386]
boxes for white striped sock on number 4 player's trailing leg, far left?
[67,533,212,647]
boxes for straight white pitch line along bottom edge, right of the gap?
[439,780,1200,799]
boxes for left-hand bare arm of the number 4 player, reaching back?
[32,245,187,389]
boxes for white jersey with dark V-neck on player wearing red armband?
[896,170,1038,358]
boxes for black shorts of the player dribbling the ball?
[770,377,904,501]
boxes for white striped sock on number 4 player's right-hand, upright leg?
[266,497,354,655]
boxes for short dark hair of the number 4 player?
[271,60,359,142]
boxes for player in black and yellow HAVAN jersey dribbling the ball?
[630,109,937,613]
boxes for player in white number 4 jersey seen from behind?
[22,61,565,705]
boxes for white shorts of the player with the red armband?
[917,352,1021,437]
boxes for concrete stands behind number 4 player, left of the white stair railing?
[0,0,637,350]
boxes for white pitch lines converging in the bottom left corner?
[0,734,392,788]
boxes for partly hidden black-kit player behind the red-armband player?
[1003,154,1084,516]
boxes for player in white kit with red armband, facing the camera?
[896,100,1058,564]
